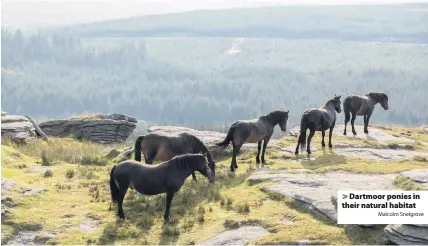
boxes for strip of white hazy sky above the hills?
[1,0,428,29]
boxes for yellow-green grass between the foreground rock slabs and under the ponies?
[1,126,427,244]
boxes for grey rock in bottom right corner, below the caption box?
[384,225,428,245]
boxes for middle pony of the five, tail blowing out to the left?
[216,110,289,172]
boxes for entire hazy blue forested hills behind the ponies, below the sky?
[1,4,428,129]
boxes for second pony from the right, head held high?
[295,95,342,155]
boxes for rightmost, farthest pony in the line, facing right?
[343,92,389,135]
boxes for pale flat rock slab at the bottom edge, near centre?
[198,226,269,245]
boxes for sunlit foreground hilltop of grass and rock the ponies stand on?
[1,126,428,244]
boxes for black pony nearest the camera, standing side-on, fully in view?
[110,154,215,222]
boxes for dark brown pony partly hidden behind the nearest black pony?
[134,132,215,180]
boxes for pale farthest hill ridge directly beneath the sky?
[55,4,428,43]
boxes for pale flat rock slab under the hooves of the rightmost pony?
[333,124,415,143]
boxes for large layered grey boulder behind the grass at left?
[39,114,137,144]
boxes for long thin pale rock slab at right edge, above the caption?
[334,148,428,161]
